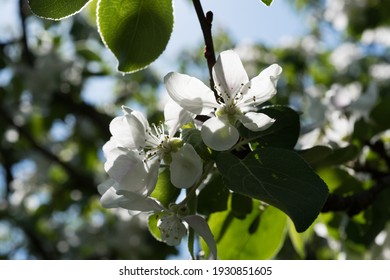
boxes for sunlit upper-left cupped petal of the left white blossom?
[110,108,148,149]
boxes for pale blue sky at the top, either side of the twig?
[155,0,306,71]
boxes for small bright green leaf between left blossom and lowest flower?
[150,168,180,208]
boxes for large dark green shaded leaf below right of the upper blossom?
[216,147,328,232]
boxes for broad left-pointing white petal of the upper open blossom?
[164,72,219,115]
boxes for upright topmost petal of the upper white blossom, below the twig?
[213,50,249,101]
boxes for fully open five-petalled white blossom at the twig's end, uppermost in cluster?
[164,50,282,151]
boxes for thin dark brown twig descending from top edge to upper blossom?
[192,0,218,100]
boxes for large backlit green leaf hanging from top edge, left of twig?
[98,0,173,73]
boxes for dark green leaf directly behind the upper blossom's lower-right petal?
[239,105,300,149]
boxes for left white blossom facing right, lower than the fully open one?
[103,102,203,190]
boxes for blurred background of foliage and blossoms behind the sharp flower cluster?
[0,0,390,259]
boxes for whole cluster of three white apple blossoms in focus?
[98,50,282,257]
